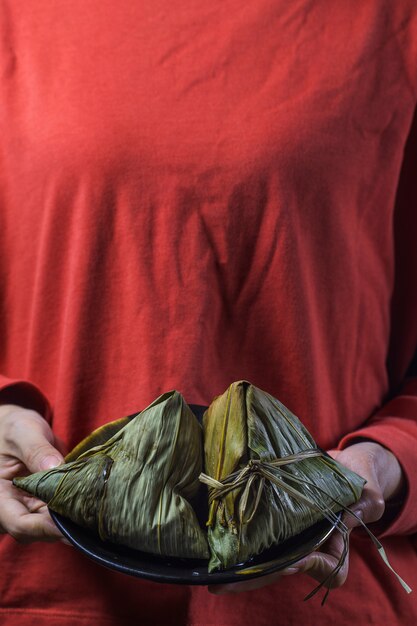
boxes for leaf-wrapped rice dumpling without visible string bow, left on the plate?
[14,391,209,558]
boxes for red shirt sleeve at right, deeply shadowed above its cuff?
[339,109,417,536]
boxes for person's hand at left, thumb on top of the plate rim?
[0,404,64,543]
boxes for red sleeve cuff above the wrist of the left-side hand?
[0,374,52,422]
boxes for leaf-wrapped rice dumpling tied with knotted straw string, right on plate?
[201,381,365,571]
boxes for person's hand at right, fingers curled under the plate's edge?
[209,441,404,594]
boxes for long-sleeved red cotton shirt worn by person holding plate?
[0,0,417,626]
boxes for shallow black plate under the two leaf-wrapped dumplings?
[50,405,335,585]
